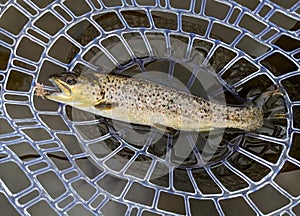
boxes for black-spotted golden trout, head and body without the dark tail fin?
[46,73,263,131]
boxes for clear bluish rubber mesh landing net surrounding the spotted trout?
[0,0,300,215]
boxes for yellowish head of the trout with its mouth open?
[45,72,95,108]
